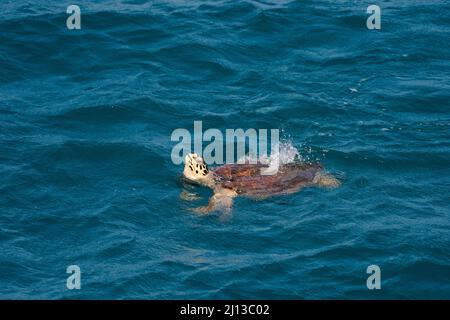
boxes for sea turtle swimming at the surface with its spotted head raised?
[183,153,341,213]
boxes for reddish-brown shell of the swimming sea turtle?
[213,163,323,197]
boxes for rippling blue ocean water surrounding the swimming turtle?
[0,0,450,299]
